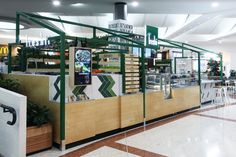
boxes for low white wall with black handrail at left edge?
[0,88,26,157]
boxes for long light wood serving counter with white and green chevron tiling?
[5,74,200,144]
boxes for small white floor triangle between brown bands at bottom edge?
[82,146,139,157]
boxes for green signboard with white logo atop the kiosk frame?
[145,26,159,49]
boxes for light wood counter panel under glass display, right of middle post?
[146,86,200,120]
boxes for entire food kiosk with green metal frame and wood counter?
[5,13,223,148]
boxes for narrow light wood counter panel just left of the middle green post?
[121,93,143,128]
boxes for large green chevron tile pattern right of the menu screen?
[97,75,116,98]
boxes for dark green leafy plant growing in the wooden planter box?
[27,101,52,127]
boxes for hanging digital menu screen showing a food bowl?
[74,48,92,85]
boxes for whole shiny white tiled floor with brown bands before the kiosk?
[29,102,236,157]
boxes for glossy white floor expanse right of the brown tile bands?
[118,106,236,157]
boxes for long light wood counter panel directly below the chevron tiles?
[66,97,120,144]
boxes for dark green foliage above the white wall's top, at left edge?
[0,77,20,93]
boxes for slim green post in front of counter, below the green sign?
[141,48,146,126]
